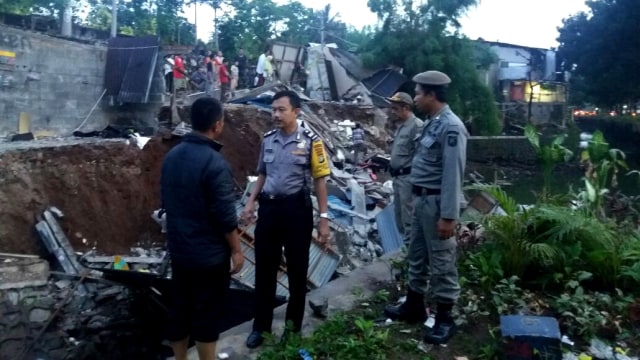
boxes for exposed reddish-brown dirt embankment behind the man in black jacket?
[0,107,270,254]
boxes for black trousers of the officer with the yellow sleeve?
[253,192,313,332]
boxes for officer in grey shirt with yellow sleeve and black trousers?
[242,90,331,349]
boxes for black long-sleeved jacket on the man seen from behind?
[161,133,238,268]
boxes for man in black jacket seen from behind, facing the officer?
[161,98,244,360]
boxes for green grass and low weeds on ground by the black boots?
[259,283,495,360]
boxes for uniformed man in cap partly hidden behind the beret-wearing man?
[388,92,423,248]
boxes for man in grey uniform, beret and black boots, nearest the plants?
[385,70,469,344]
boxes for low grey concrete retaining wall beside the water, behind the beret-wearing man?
[467,136,538,165]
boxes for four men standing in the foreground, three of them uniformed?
[161,71,468,360]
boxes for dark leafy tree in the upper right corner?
[558,0,640,108]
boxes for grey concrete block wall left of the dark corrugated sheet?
[0,25,107,138]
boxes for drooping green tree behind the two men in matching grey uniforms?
[362,0,501,135]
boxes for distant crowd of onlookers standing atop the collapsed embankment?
[163,47,278,102]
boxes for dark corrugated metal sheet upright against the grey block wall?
[105,36,160,103]
